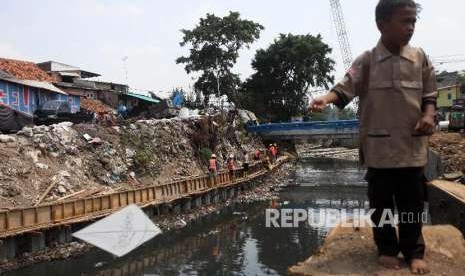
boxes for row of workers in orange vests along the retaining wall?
[208,144,278,186]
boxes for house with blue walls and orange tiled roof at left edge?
[0,58,80,130]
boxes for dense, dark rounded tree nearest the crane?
[240,34,334,121]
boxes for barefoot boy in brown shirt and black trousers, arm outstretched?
[310,0,437,274]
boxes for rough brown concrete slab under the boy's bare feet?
[289,225,465,276]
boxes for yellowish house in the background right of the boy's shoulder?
[437,71,465,118]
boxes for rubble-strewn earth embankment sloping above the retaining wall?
[0,114,263,209]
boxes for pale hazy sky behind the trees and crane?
[0,0,465,97]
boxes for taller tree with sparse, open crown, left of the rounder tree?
[176,12,264,104]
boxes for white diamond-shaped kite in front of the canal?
[72,204,161,257]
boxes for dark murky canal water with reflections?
[7,159,368,276]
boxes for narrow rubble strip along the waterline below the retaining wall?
[0,161,295,274]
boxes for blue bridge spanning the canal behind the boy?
[247,120,359,140]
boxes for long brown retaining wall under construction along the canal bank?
[0,157,287,259]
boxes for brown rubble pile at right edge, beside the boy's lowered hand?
[430,132,465,173]
